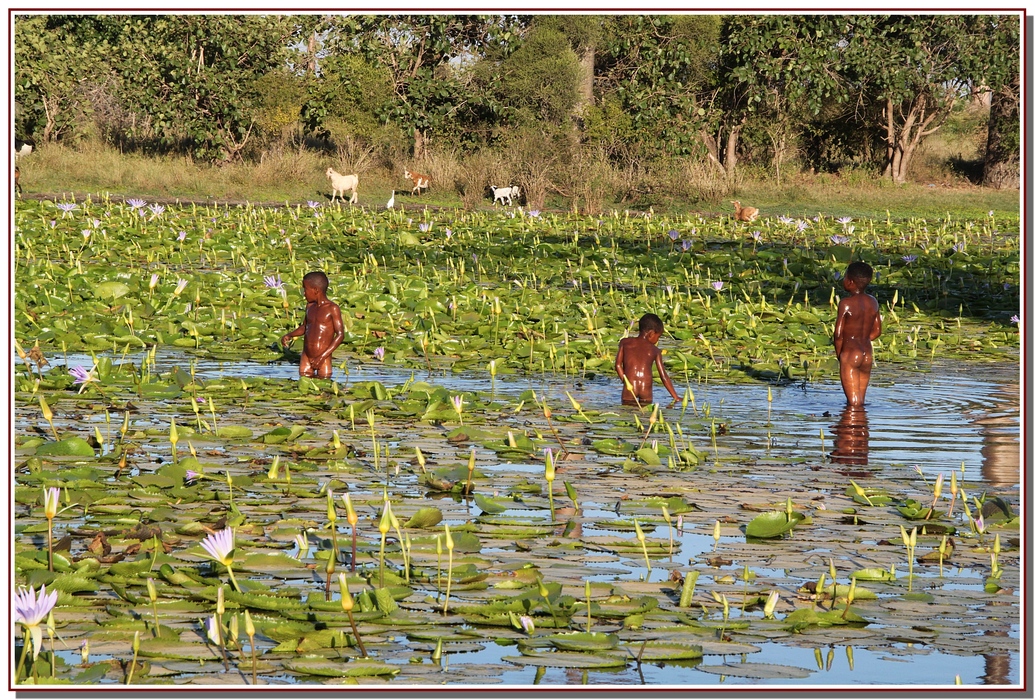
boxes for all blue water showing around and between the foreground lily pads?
[16,351,1021,688]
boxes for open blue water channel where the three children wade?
[46,350,1021,487]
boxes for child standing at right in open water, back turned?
[834,261,881,406]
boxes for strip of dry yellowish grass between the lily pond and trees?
[19,138,1021,217]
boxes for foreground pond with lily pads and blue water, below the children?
[13,351,1021,688]
